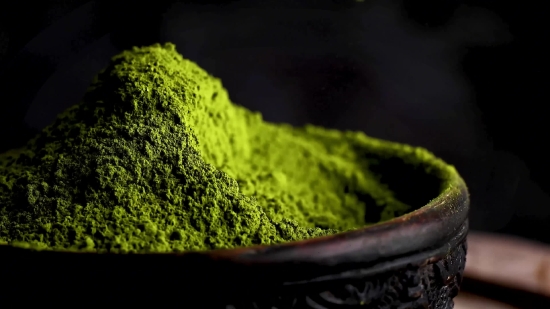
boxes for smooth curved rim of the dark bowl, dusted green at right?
[207,142,470,266]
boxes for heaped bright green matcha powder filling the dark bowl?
[0,44,408,252]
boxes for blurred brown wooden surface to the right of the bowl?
[455,232,550,309]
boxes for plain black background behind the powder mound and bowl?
[0,0,550,242]
